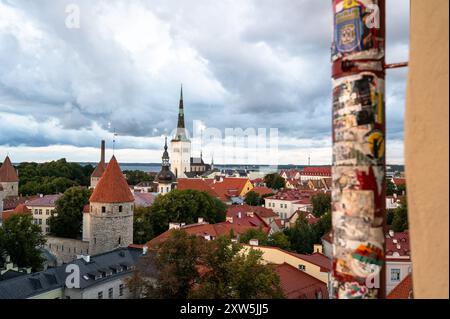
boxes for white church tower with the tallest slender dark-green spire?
[171,87,191,178]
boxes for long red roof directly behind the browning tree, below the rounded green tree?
[147,222,269,247]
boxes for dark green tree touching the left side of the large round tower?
[49,187,91,238]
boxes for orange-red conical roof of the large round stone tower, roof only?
[89,156,134,203]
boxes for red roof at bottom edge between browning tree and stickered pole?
[275,263,328,299]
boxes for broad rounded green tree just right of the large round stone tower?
[151,189,227,236]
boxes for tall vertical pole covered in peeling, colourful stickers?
[331,0,386,299]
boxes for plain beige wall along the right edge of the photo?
[406,0,449,298]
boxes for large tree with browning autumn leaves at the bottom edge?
[128,230,283,299]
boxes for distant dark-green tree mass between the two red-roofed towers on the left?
[17,158,94,195]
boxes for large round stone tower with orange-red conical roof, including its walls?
[83,156,134,255]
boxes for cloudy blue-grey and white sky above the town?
[0,0,409,164]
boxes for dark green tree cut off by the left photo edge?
[0,214,45,271]
